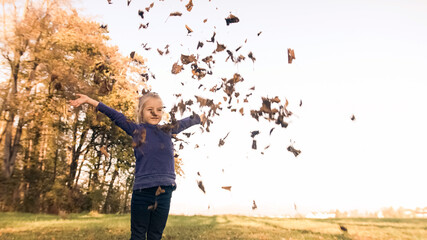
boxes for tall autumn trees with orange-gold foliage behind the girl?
[0,0,154,213]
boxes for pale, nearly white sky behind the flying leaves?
[76,0,427,216]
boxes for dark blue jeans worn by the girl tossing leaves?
[130,185,176,240]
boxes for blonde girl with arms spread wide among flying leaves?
[70,92,205,240]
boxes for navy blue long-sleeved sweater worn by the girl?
[97,102,200,190]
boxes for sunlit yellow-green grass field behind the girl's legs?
[0,213,427,240]
